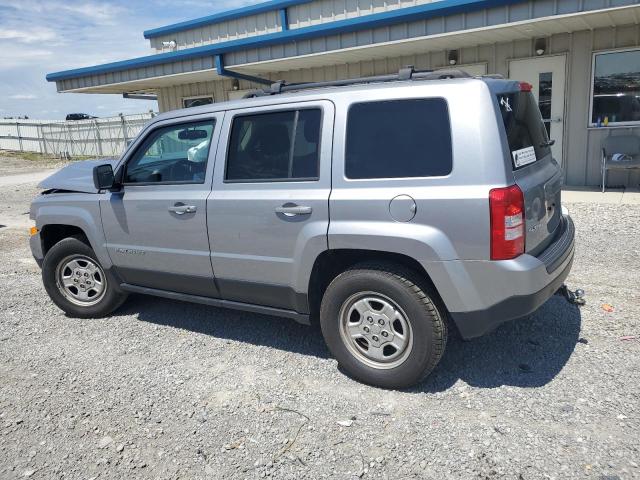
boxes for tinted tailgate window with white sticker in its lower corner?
[498,92,551,169]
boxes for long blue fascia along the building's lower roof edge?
[46,0,527,82]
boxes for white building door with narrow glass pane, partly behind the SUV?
[509,55,566,165]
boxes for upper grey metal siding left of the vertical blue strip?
[150,11,282,52]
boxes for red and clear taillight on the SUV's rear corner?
[489,185,524,260]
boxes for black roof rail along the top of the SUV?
[245,65,471,98]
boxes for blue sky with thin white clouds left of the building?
[0,0,263,120]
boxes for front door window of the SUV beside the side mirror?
[124,120,215,183]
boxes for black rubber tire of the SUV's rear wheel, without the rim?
[320,263,447,389]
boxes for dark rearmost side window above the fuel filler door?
[345,98,453,179]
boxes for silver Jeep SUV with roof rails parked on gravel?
[31,69,574,388]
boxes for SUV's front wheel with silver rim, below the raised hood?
[42,237,127,318]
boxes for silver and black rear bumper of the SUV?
[445,215,575,339]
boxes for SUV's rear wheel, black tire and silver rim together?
[320,264,447,388]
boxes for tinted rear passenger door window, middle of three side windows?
[225,109,322,181]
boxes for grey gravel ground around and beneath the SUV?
[0,174,640,479]
